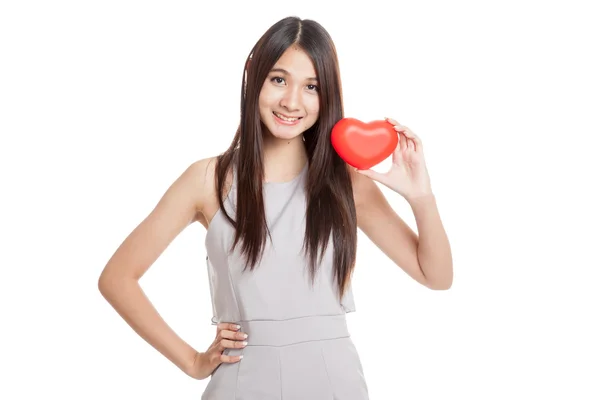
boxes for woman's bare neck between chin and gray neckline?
[263,135,308,182]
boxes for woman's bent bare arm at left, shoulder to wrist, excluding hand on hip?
[98,159,214,374]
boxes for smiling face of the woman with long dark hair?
[258,46,319,140]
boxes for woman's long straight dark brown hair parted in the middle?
[215,17,357,298]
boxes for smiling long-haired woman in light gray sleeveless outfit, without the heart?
[99,17,453,400]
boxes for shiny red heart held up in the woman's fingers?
[331,118,398,169]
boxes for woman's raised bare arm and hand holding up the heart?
[353,119,453,290]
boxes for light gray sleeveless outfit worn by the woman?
[201,164,369,400]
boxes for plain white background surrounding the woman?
[0,0,600,400]
